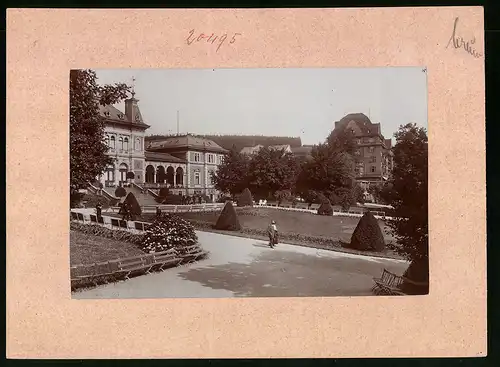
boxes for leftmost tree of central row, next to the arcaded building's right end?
[212,149,250,195]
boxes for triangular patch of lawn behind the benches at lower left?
[69,230,144,265]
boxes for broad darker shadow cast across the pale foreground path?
[178,250,407,297]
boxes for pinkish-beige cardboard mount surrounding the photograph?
[7,7,486,358]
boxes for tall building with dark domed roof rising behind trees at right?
[334,113,393,188]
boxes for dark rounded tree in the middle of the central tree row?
[248,148,299,199]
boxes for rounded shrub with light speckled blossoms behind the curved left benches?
[142,213,198,254]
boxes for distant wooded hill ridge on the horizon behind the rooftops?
[146,134,302,151]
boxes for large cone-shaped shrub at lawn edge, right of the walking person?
[346,212,385,252]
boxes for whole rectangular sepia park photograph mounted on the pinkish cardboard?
[68,66,429,299]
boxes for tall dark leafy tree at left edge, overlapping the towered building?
[69,70,133,196]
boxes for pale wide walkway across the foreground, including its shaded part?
[73,232,408,299]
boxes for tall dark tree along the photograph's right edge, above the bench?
[385,124,429,290]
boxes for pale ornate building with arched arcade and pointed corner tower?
[98,93,227,198]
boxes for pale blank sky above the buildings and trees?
[95,67,427,144]
